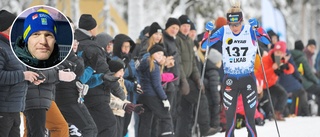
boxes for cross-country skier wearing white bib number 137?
[202,3,270,137]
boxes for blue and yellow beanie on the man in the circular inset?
[23,9,57,43]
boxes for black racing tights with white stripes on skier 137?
[222,74,257,137]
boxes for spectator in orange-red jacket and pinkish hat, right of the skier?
[255,41,294,121]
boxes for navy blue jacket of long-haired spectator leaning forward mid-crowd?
[138,58,167,100]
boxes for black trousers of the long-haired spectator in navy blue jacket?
[138,96,173,137]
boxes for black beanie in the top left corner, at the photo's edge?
[0,10,16,32]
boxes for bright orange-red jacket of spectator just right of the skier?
[255,50,294,89]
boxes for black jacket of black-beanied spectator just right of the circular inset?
[75,29,120,107]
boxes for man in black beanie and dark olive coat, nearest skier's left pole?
[176,15,204,137]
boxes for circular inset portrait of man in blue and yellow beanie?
[10,5,73,70]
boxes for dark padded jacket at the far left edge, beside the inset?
[0,34,28,112]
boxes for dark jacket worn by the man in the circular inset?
[14,37,60,68]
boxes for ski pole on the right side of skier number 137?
[253,28,280,137]
